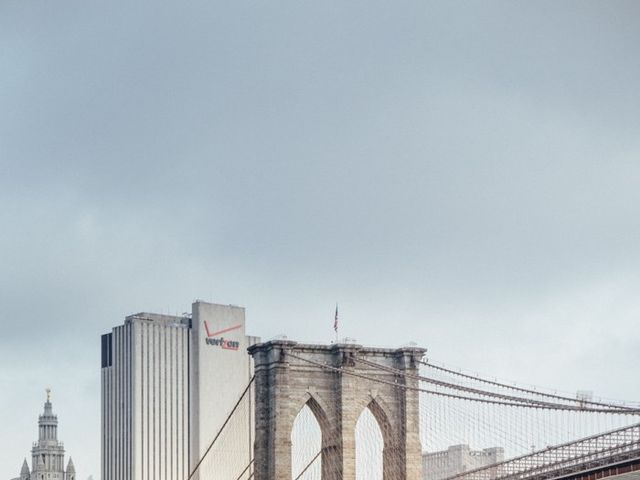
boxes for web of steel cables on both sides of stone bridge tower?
[188,348,640,480]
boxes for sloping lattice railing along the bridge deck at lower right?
[446,423,640,480]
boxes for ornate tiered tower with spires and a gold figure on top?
[13,390,76,480]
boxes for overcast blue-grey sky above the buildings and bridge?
[0,0,640,479]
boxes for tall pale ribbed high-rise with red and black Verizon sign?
[101,301,259,480]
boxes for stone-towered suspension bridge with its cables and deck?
[185,340,640,480]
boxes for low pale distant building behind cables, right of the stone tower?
[422,445,504,480]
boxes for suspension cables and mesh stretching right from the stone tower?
[288,353,640,480]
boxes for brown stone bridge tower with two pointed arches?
[249,340,425,480]
